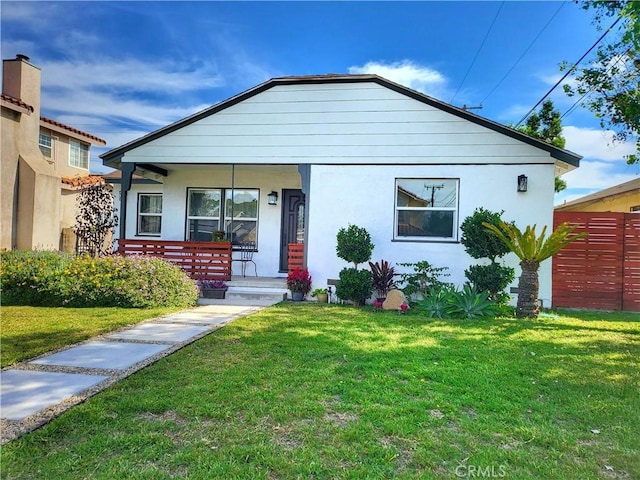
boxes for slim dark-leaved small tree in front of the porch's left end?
[73,183,118,257]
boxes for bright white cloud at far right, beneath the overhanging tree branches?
[562,126,636,163]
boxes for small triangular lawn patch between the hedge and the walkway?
[0,307,186,368]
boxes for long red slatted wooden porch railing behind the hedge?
[118,239,231,281]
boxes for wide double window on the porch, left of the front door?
[187,188,259,244]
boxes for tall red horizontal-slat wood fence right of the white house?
[552,212,640,312]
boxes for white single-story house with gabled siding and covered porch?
[101,75,581,306]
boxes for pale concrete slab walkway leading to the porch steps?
[0,300,276,444]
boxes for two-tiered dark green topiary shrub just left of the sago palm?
[460,207,515,302]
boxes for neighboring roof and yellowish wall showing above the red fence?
[556,178,640,213]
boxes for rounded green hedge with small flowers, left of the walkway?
[0,250,198,308]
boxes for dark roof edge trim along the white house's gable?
[100,74,582,168]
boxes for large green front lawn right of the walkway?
[2,303,640,480]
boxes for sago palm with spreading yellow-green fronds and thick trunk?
[483,221,587,317]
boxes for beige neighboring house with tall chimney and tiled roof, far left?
[0,55,106,251]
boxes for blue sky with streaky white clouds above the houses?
[0,1,640,204]
